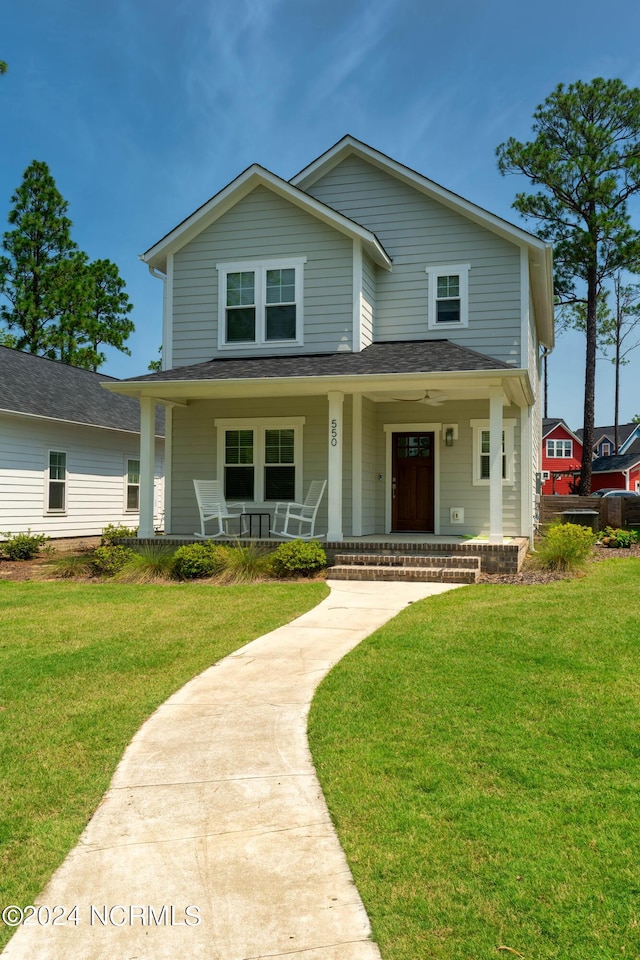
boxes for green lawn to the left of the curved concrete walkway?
[0,581,327,947]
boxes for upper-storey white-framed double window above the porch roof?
[216,257,306,349]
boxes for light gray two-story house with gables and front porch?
[108,136,554,543]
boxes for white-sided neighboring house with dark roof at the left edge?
[0,347,164,537]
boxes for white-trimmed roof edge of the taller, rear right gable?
[291,134,554,348]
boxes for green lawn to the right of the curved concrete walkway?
[310,560,640,960]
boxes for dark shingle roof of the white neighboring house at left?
[0,347,163,435]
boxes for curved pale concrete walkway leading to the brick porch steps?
[2,581,452,960]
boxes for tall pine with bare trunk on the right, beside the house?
[497,78,640,495]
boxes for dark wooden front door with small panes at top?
[391,433,434,533]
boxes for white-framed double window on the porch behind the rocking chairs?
[215,417,305,504]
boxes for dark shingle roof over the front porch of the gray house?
[124,340,514,382]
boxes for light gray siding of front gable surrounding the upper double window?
[173,187,353,366]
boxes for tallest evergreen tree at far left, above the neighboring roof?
[0,160,76,353]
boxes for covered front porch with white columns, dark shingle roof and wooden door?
[104,341,534,546]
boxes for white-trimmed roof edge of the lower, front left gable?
[140,163,391,272]
